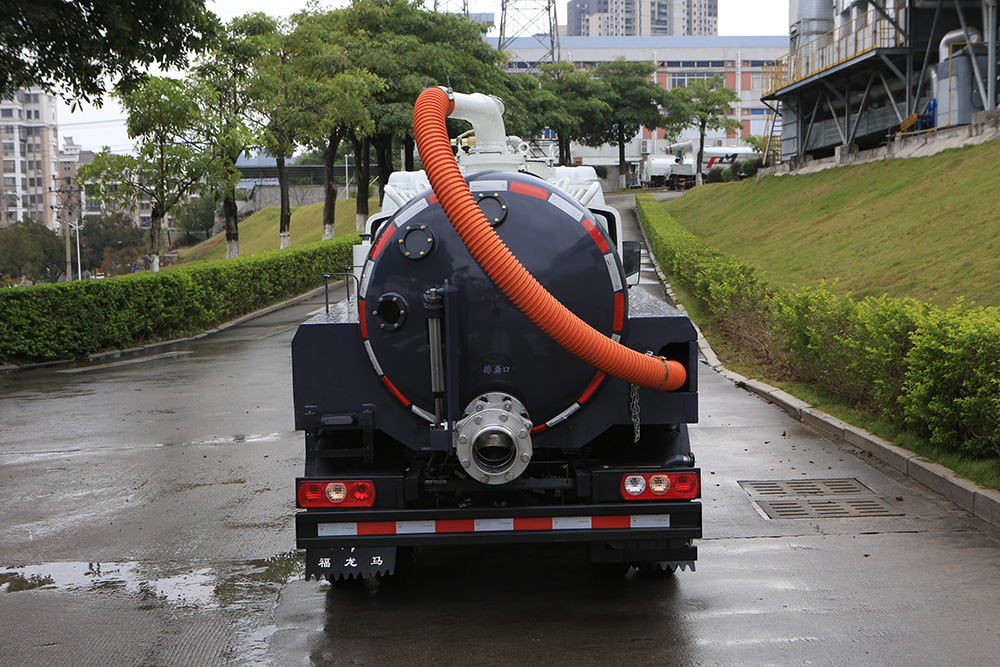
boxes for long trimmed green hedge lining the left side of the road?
[0,234,359,365]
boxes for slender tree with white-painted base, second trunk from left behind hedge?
[194,13,276,259]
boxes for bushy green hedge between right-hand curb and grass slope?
[637,195,1000,457]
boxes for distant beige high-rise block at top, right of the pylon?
[565,0,719,37]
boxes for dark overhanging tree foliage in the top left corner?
[0,0,217,104]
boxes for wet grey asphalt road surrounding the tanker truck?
[0,199,1000,665]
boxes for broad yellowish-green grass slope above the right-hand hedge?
[664,140,1000,307]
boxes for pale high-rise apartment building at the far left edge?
[0,87,60,230]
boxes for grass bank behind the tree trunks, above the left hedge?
[179,197,379,263]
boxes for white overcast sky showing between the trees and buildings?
[58,0,788,153]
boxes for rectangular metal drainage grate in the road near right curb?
[739,478,902,519]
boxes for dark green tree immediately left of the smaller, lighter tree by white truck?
[584,58,680,188]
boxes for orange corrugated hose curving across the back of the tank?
[413,88,687,391]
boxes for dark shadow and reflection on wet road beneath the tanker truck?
[310,546,699,665]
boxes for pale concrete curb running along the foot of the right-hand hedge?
[636,202,1000,528]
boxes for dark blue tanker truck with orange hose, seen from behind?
[292,88,702,580]
